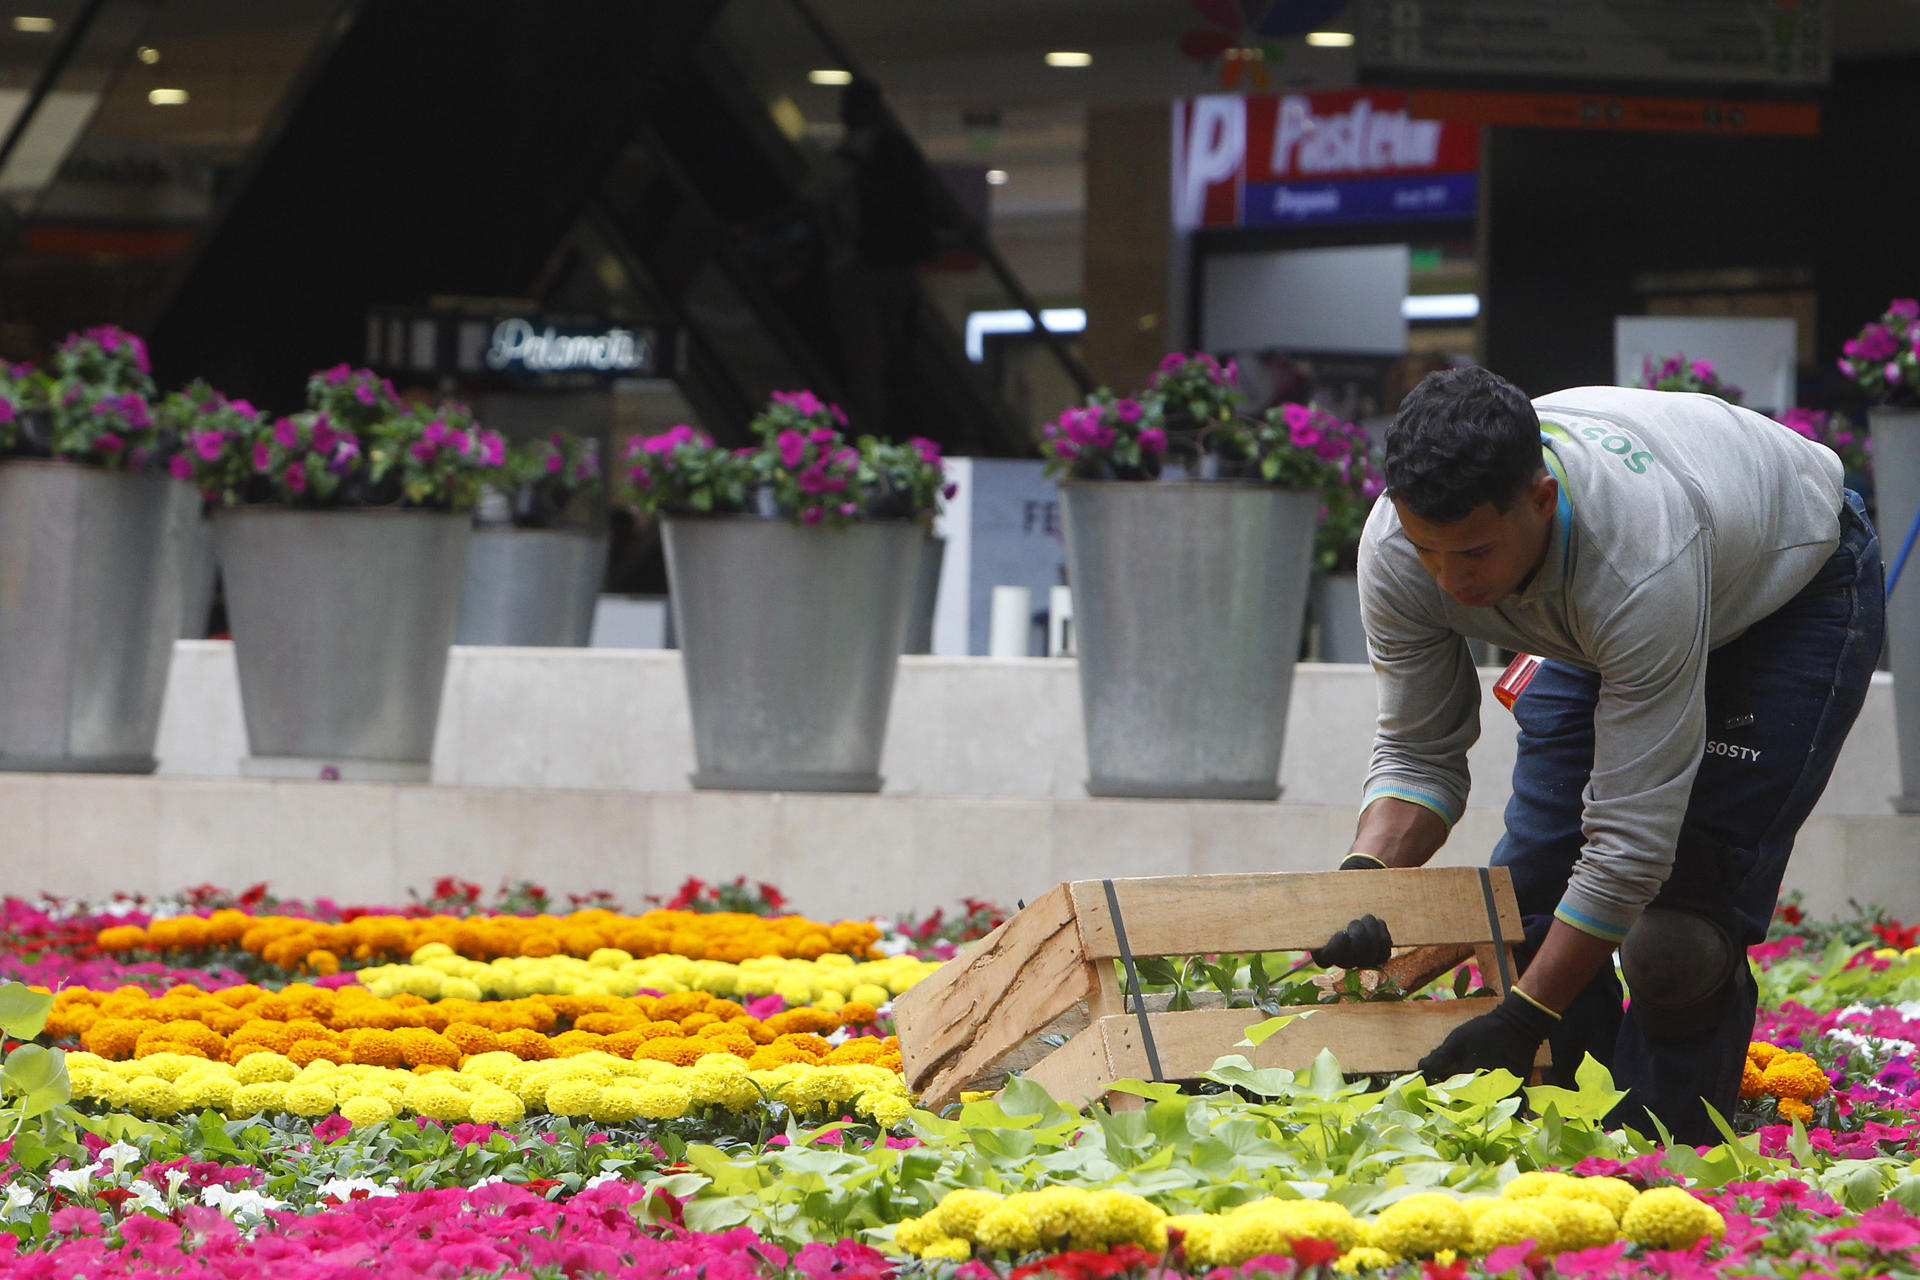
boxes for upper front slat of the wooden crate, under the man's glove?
[1068,867,1521,960]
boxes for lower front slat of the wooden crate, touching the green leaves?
[1025,996,1500,1107]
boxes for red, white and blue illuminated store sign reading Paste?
[1173,90,1480,230]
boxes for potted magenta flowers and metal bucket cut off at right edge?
[1839,297,1920,814]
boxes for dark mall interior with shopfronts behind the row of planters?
[0,0,1920,591]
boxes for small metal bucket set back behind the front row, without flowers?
[453,528,607,649]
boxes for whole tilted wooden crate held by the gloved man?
[893,867,1544,1109]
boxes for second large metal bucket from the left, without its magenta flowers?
[213,507,470,781]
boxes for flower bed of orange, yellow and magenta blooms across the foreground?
[11,892,1920,1280]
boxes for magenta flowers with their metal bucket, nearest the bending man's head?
[1041,353,1367,800]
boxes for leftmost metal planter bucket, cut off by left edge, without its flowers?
[0,461,200,773]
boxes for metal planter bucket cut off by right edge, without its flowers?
[1868,407,1920,814]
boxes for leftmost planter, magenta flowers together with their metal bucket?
[0,324,198,773]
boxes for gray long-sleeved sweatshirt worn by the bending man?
[1359,388,1841,942]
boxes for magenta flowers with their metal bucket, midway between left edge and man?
[622,391,943,791]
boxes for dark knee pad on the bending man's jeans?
[1620,906,1745,1044]
